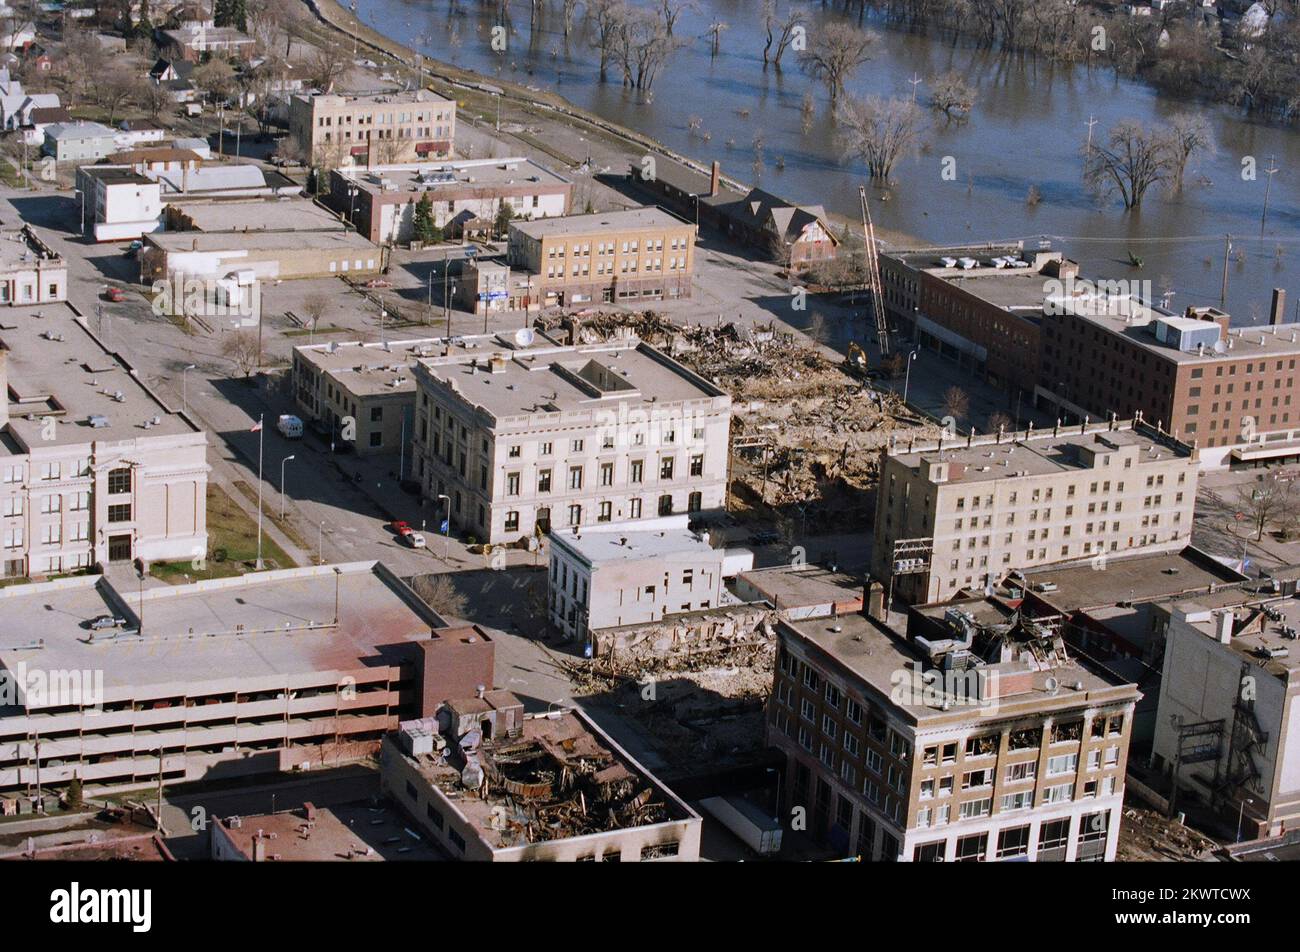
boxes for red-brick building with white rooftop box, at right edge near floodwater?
[1039,289,1300,467]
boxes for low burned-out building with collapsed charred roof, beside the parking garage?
[381,691,702,862]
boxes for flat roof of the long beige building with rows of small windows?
[889,421,1191,484]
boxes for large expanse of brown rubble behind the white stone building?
[538,311,939,532]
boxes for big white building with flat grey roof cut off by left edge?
[0,306,208,576]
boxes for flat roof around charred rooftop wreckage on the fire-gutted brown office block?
[780,613,1134,723]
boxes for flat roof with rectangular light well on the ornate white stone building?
[420,338,729,419]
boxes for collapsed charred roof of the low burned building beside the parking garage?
[400,710,699,849]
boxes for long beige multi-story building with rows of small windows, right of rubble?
[871,420,1199,603]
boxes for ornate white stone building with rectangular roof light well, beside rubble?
[411,336,731,542]
